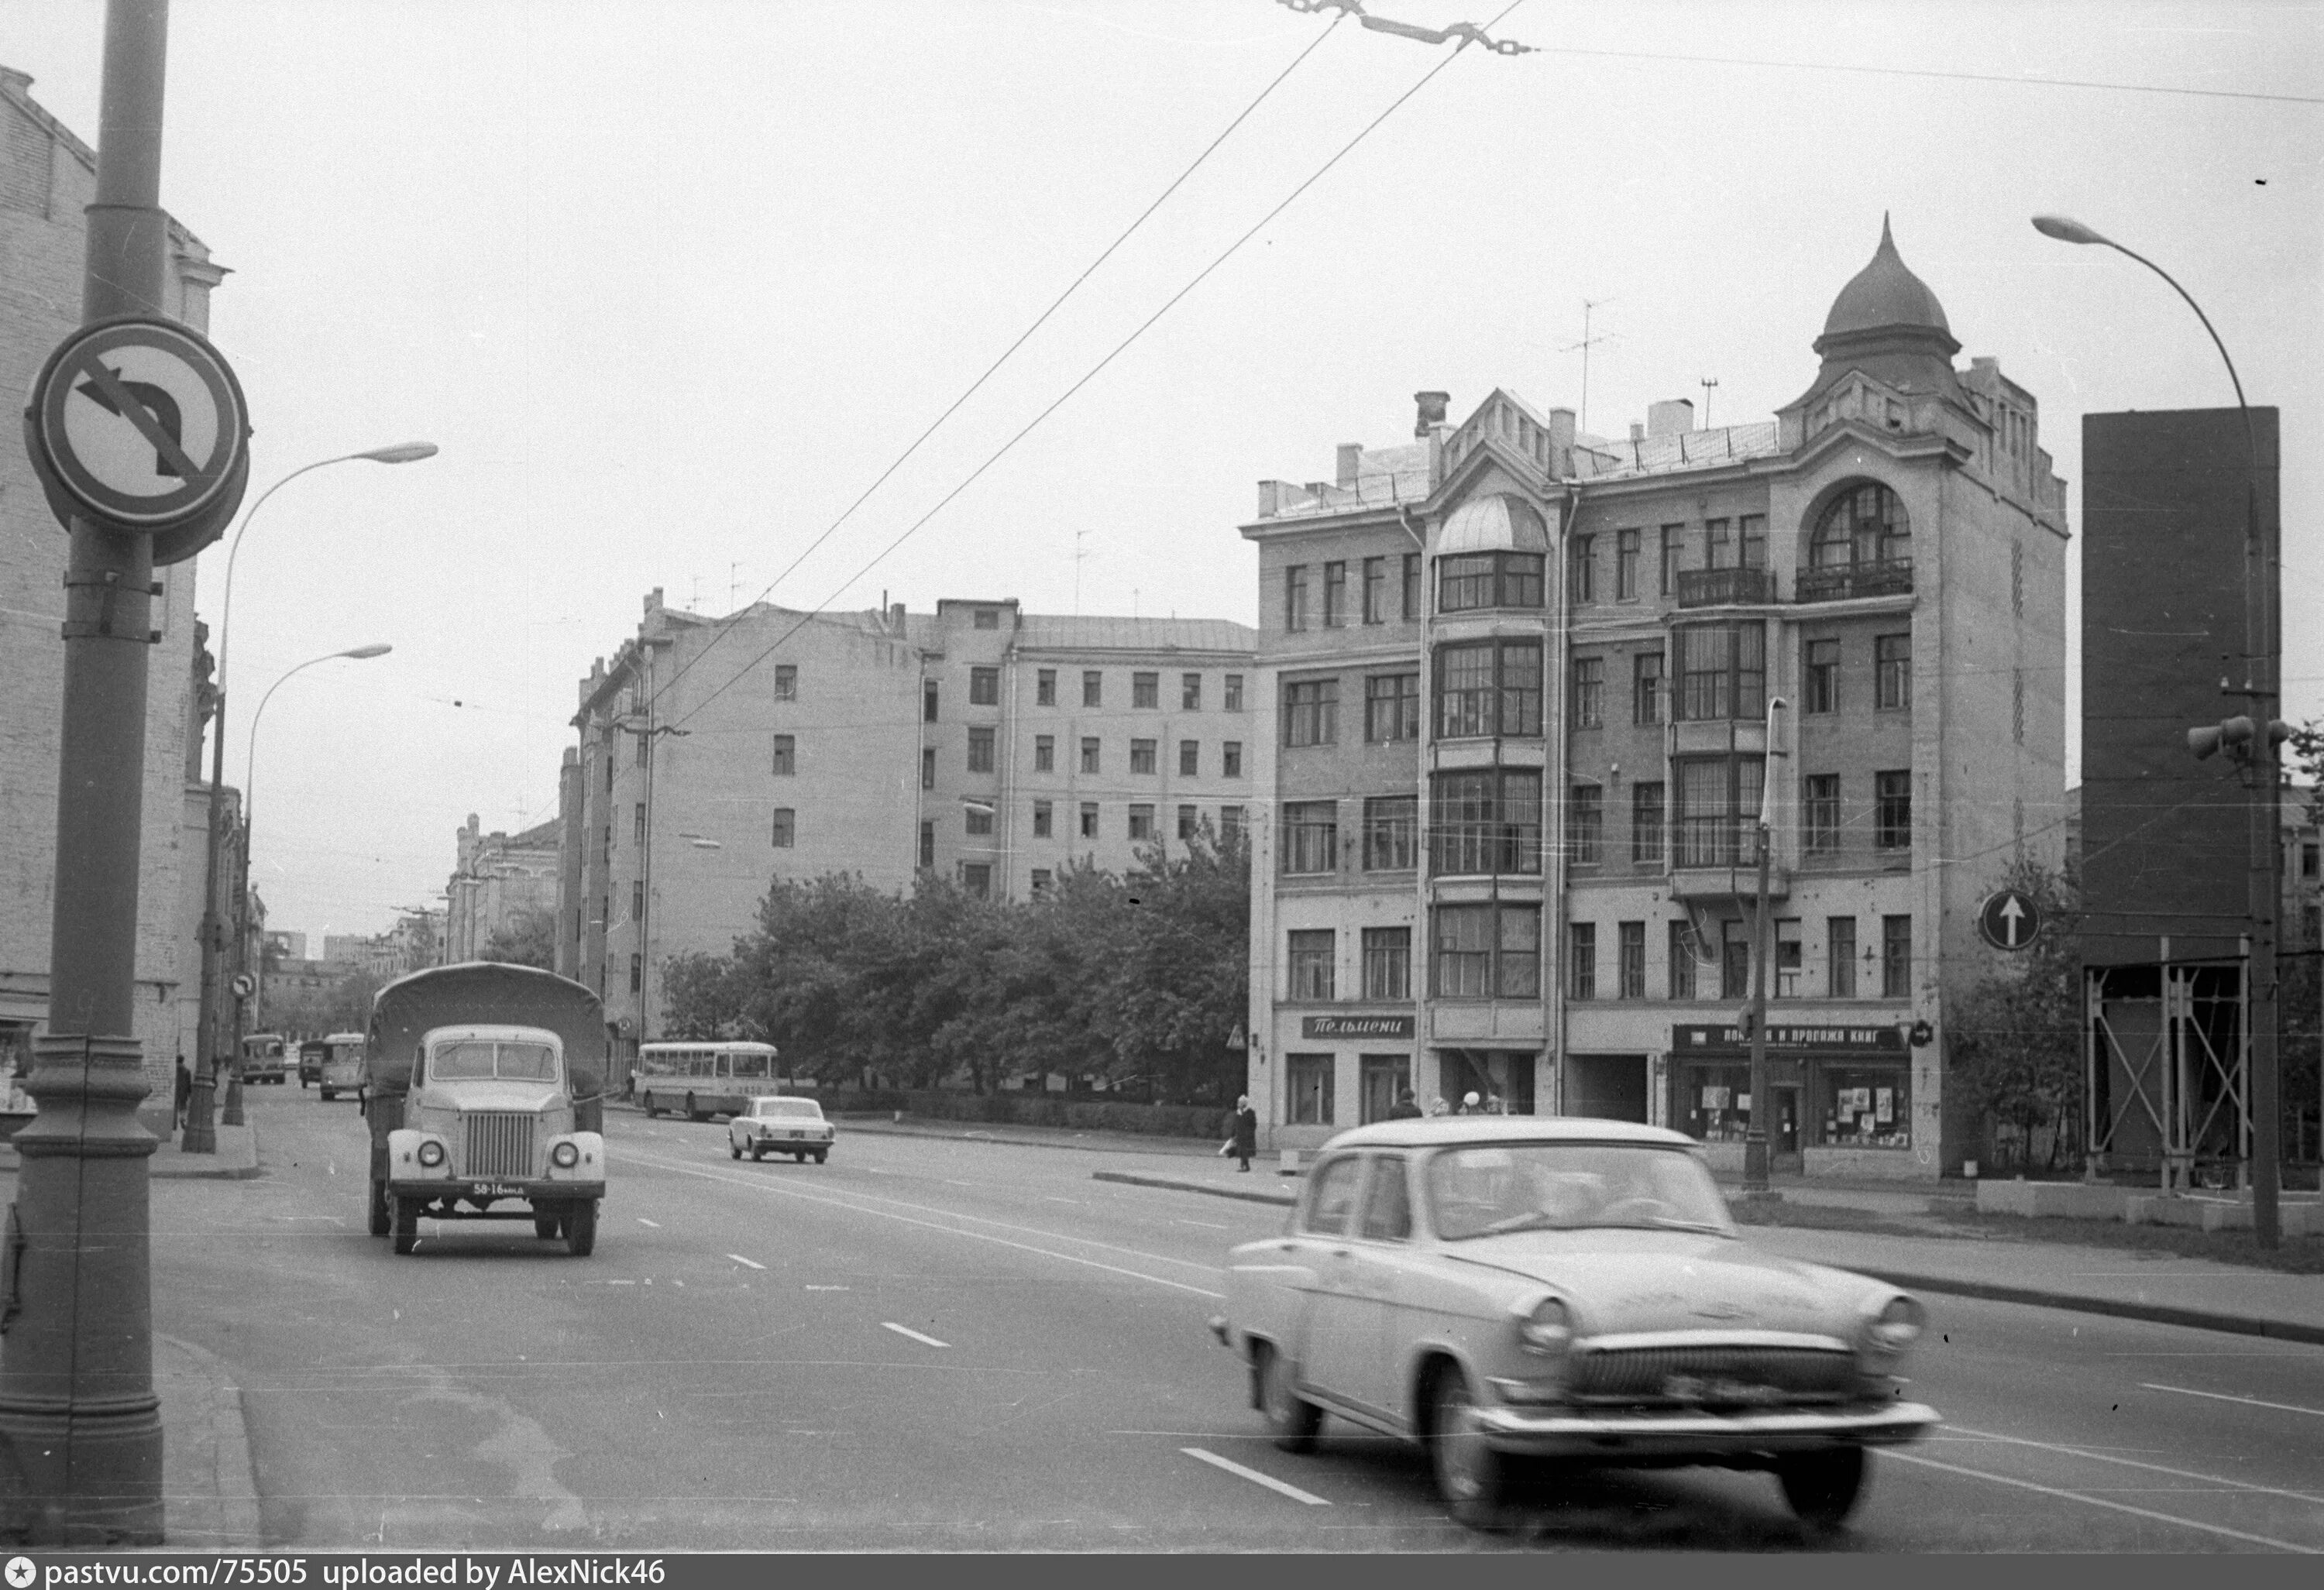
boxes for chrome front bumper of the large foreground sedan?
[1478,1402,1941,1462]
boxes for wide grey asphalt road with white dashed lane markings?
[153,1088,2324,1553]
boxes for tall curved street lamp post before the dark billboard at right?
[2033,216,2282,1248]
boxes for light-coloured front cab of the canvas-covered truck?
[383,1023,604,1258]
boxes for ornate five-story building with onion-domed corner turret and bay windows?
[1243,228,2066,1176]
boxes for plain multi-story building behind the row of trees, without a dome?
[558,590,1257,1073]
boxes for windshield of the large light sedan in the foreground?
[1427,1144,1734,1241]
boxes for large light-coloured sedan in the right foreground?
[1211,1116,1938,1527]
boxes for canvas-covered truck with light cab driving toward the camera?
[363,960,607,1258]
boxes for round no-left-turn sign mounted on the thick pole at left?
[26,316,251,532]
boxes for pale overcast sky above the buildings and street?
[0,0,2324,944]
